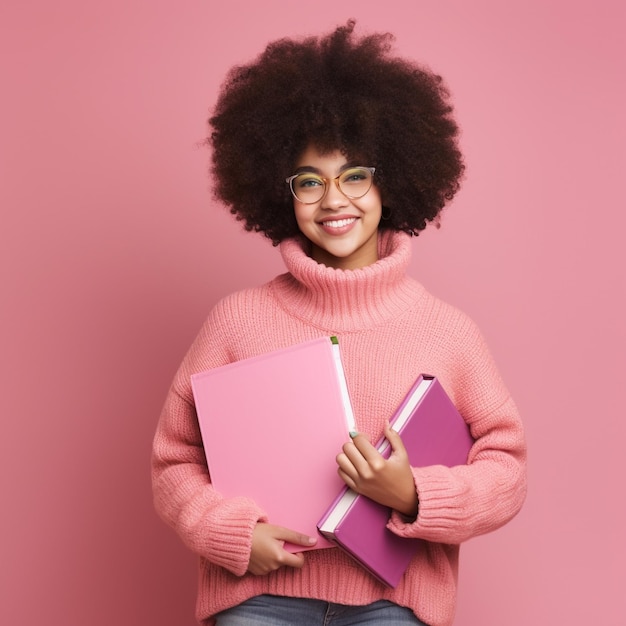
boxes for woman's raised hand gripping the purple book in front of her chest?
[337,423,418,519]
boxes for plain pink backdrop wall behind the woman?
[0,0,626,626]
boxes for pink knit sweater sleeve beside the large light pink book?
[152,318,267,576]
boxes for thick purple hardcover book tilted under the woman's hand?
[318,374,473,587]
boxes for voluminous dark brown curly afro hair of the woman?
[208,20,464,245]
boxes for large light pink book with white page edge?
[191,337,354,552]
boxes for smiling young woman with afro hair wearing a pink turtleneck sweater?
[153,22,526,626]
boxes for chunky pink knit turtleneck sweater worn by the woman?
[152,233,526,626]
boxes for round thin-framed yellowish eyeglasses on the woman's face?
[285,167,376,204]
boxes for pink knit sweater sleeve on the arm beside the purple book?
[388,320,526,544]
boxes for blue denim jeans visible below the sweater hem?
[216,595,426,626]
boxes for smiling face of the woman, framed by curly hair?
[294,146,382,269]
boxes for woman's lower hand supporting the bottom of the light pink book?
[248,522,317,575]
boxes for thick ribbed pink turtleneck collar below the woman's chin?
[272,231,423,333]
